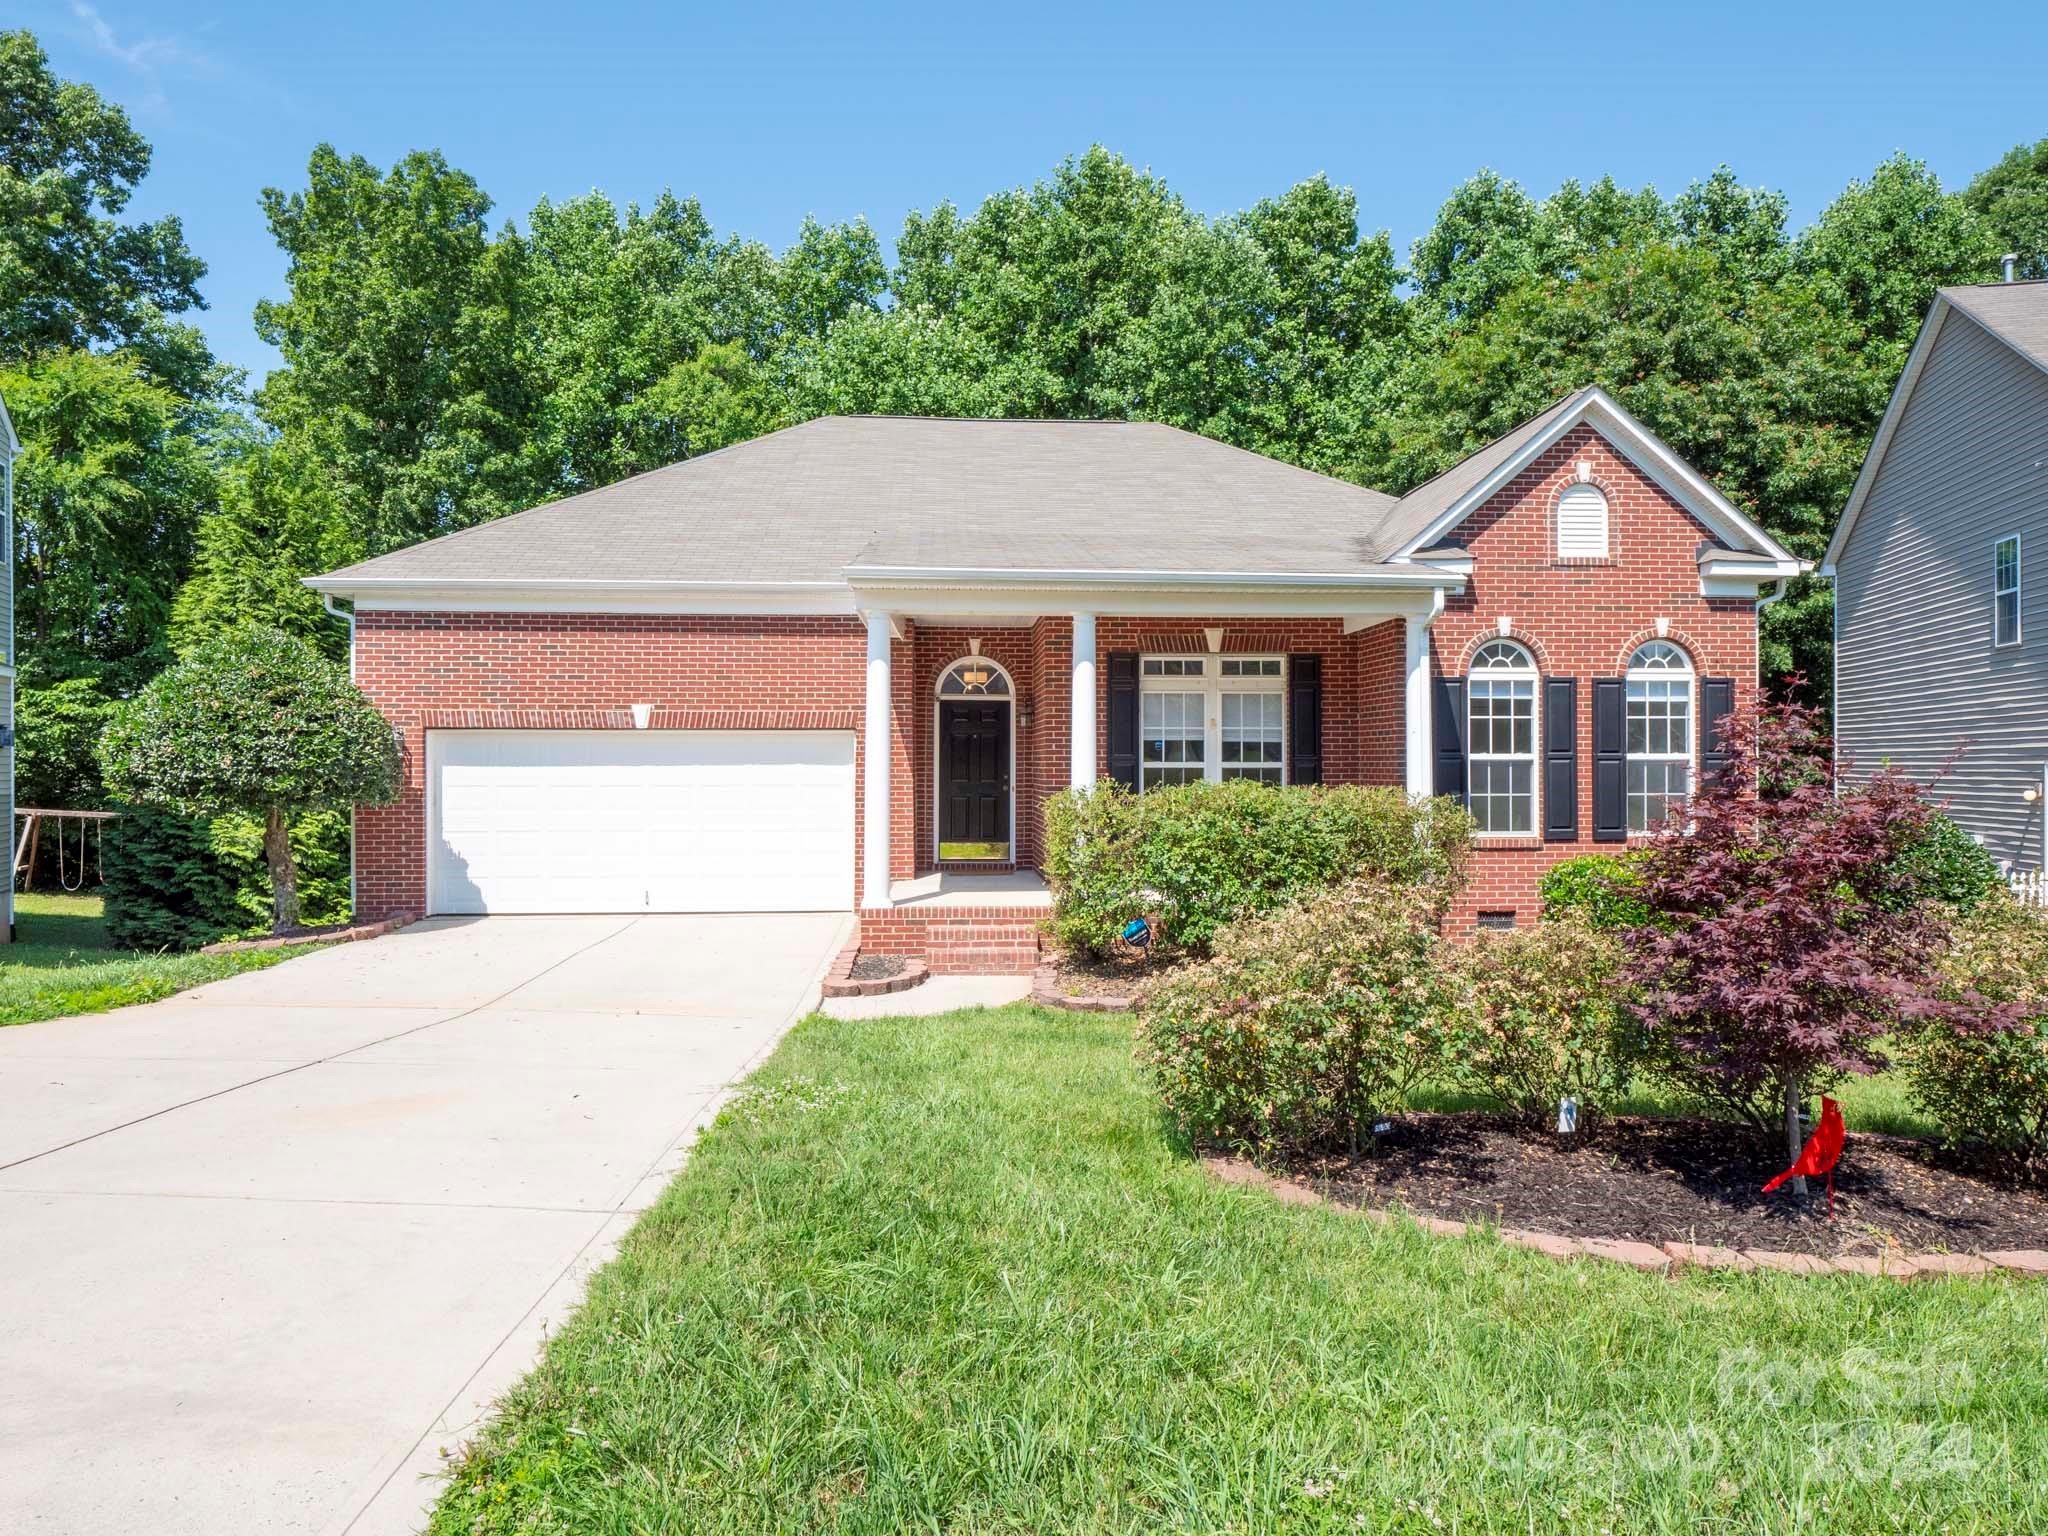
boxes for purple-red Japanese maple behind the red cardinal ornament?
[1630,702,1946,1187]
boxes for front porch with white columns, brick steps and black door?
[860,593,1442,971]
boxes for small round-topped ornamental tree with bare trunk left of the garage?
[100,629,399,934]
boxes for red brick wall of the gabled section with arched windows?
[1433,426,1757,924]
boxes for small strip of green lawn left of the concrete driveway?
[0,893,305,1026]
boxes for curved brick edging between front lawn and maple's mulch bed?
[1202,1155,2048,1280]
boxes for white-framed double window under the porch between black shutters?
[1139,655,1286,788]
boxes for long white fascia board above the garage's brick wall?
[305,575,854,614]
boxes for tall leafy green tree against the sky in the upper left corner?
[0,31,219,397]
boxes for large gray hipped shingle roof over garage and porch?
[319,416,1395,590]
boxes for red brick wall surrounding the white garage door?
[356,612,864,920]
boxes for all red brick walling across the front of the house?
[356,417,1757,937]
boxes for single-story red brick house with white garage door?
[311,389,1800,971]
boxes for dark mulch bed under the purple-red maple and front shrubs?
[1286,1114,2048,1257]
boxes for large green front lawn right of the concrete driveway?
[432,1006,2048,1536]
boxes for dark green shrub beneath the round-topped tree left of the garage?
[104,805,264,950]
